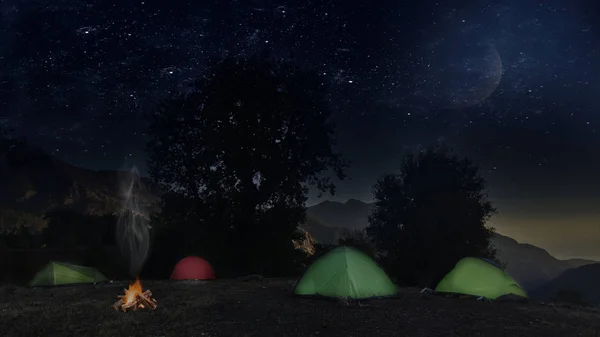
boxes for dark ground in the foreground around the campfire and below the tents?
[0,279,600,337]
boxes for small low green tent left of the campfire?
[29,261,106,287]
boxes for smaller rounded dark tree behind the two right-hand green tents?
[367,147,496,287]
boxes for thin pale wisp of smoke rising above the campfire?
[117,166,150,277]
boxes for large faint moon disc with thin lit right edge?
[419,38,503,109]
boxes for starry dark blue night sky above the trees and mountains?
[0,0,600,259]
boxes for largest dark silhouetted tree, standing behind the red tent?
[148,58,345,275]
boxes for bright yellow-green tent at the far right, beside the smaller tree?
[435,257,527,300]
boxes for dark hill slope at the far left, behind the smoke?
[0,139,159,231]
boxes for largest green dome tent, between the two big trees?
[294,247,398,299]
